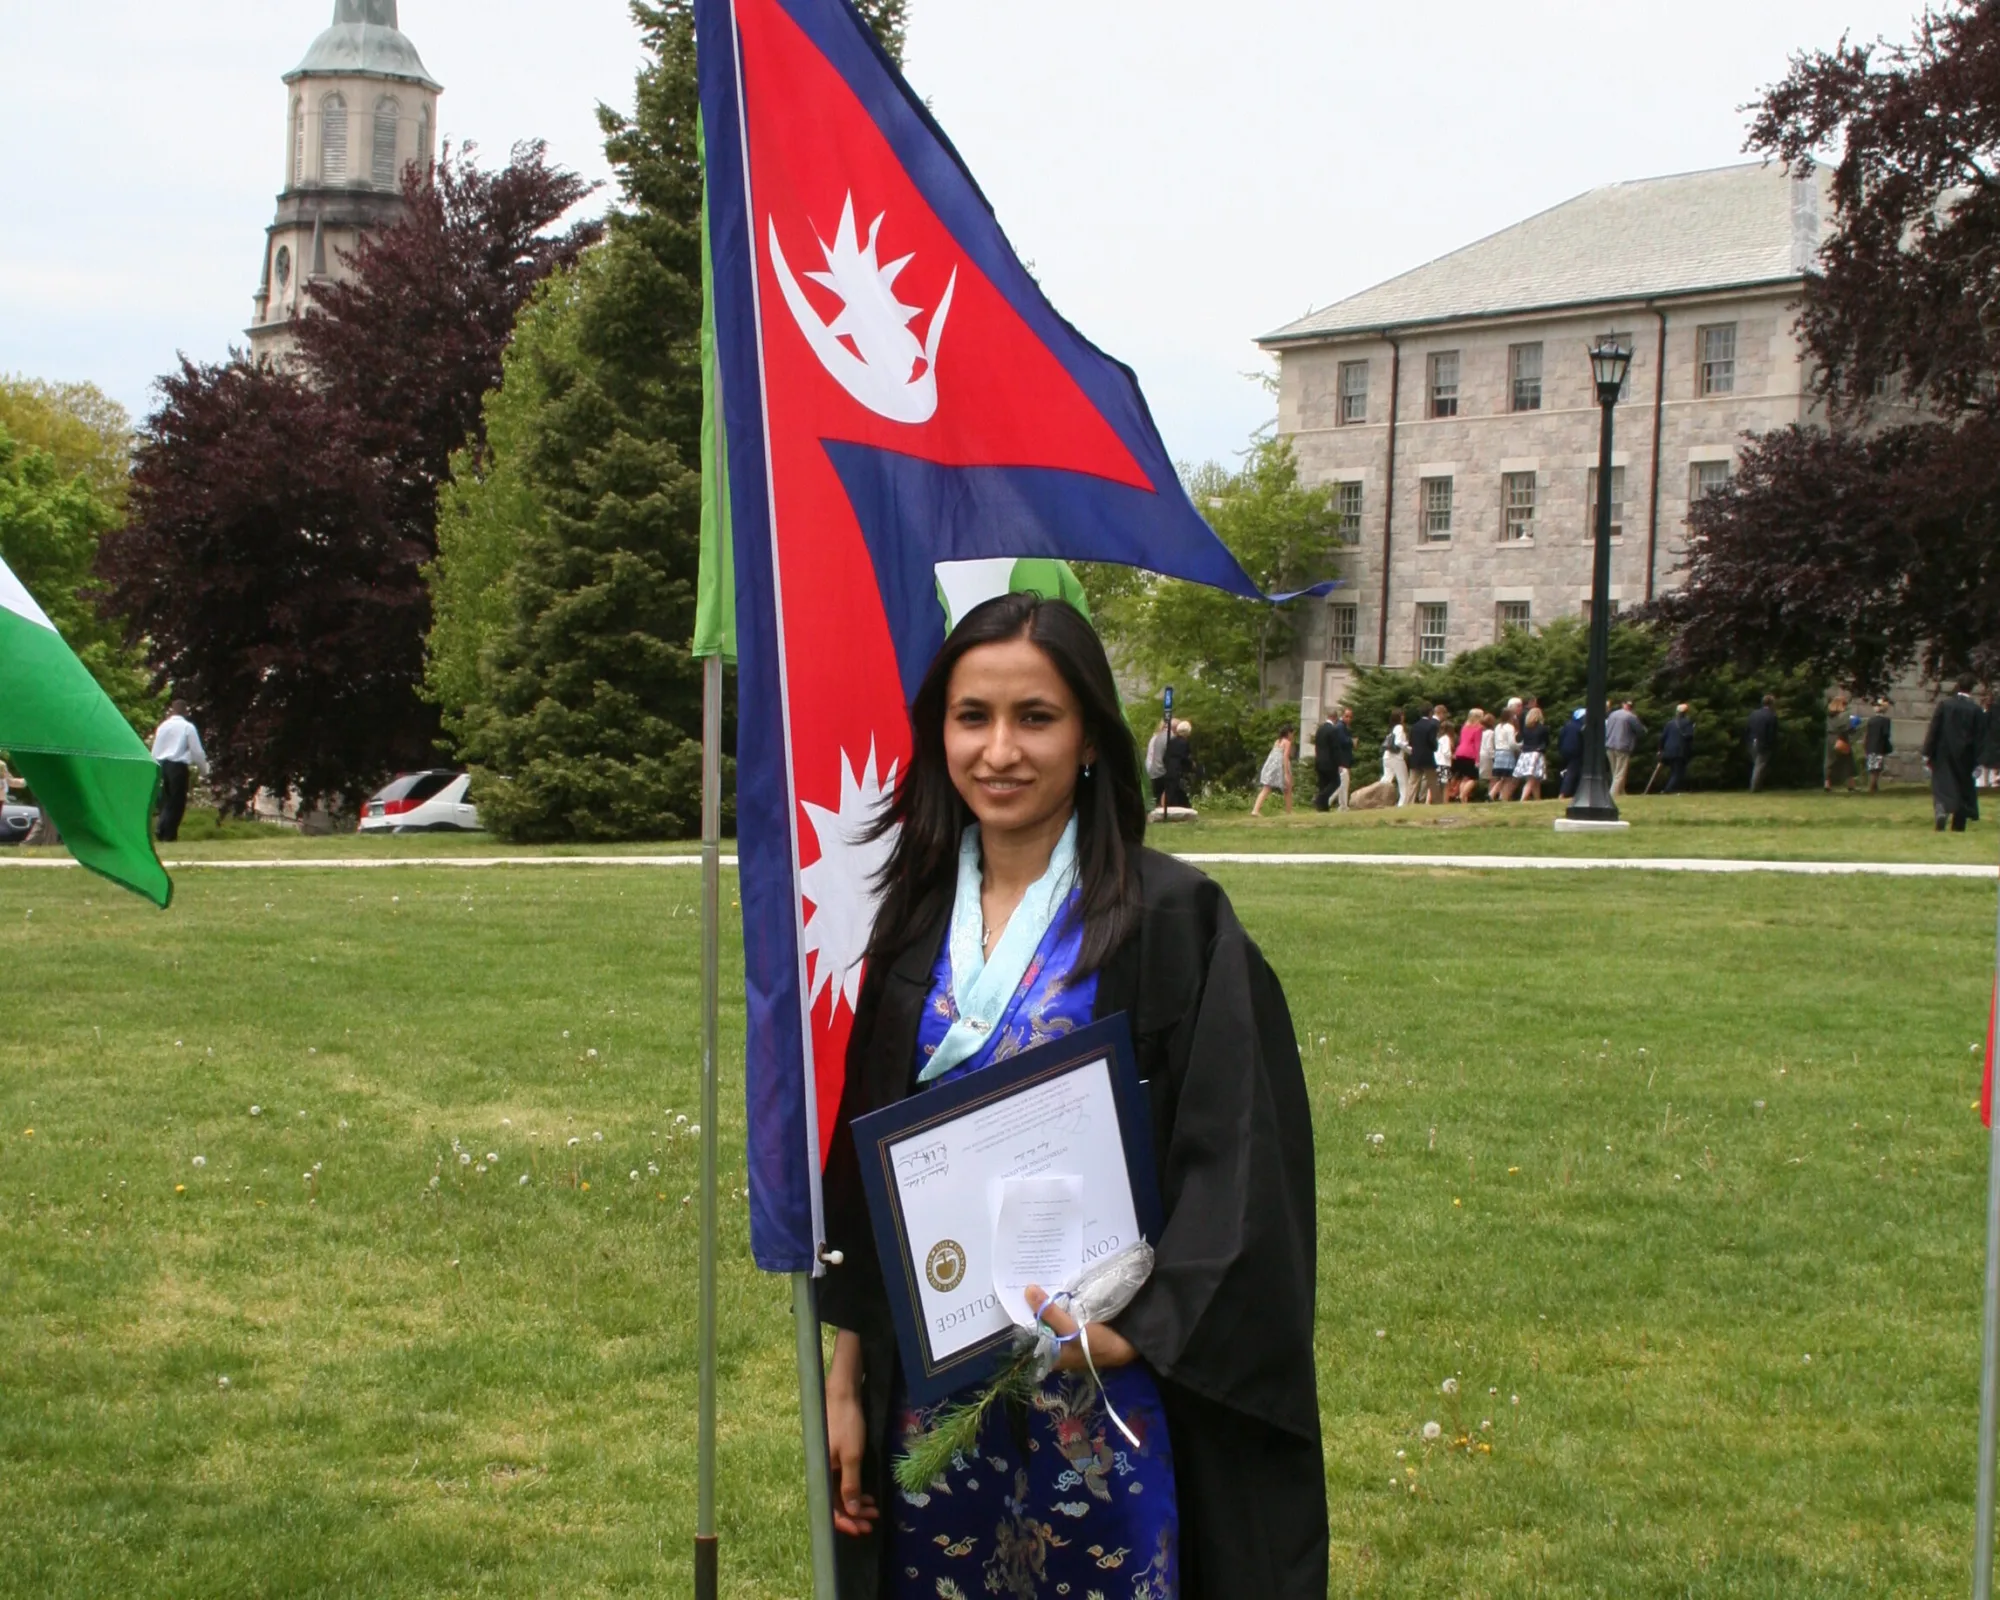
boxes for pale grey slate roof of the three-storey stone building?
[1258,162,1832,346]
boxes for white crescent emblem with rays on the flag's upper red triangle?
[770,194,958,422]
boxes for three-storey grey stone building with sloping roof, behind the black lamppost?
[1258,164,1830,728]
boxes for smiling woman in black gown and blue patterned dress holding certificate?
[820,594,1328,1600]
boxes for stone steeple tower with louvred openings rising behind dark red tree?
[248,0,442,360]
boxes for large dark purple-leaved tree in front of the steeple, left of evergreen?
[98,144,600,802]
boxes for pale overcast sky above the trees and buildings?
[0,0,1916,460]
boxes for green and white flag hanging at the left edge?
[0,562,174,908]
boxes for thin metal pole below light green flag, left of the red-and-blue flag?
[694,652,722,1600]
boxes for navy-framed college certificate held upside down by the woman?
[854,1012,1160,1406]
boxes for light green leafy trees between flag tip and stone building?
[1084,438,1338,786]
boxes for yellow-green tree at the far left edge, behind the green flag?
[0,422,160,736]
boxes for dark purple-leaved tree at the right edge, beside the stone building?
[1656,0,2000,692]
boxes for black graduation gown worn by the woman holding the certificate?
[820,850,1328,1600]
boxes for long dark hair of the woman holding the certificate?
[868,594,1146,972]
